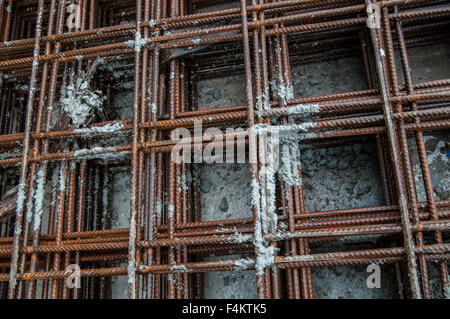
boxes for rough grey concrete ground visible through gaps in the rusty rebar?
[103,33,450,299]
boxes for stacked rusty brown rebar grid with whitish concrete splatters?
[0,0,450,299]
